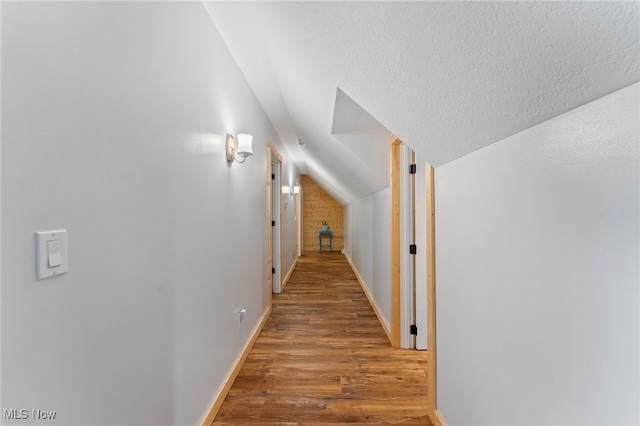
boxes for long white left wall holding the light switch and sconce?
[1,2,294,425]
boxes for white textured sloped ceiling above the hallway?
[204,1,640,204]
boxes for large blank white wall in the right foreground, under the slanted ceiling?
[436,84,640,425]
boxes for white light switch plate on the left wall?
[36,230,67,280]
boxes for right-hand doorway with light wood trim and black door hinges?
[390,136,437,421]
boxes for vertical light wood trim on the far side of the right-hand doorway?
[389,135,402,348]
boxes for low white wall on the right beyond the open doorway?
[344,188,391,326]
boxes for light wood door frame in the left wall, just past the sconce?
[267,141,282,298]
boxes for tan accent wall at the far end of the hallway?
[302,175,344,251]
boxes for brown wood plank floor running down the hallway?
[214,252,432,425]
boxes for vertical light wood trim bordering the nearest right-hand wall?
[425,164,444,425]
